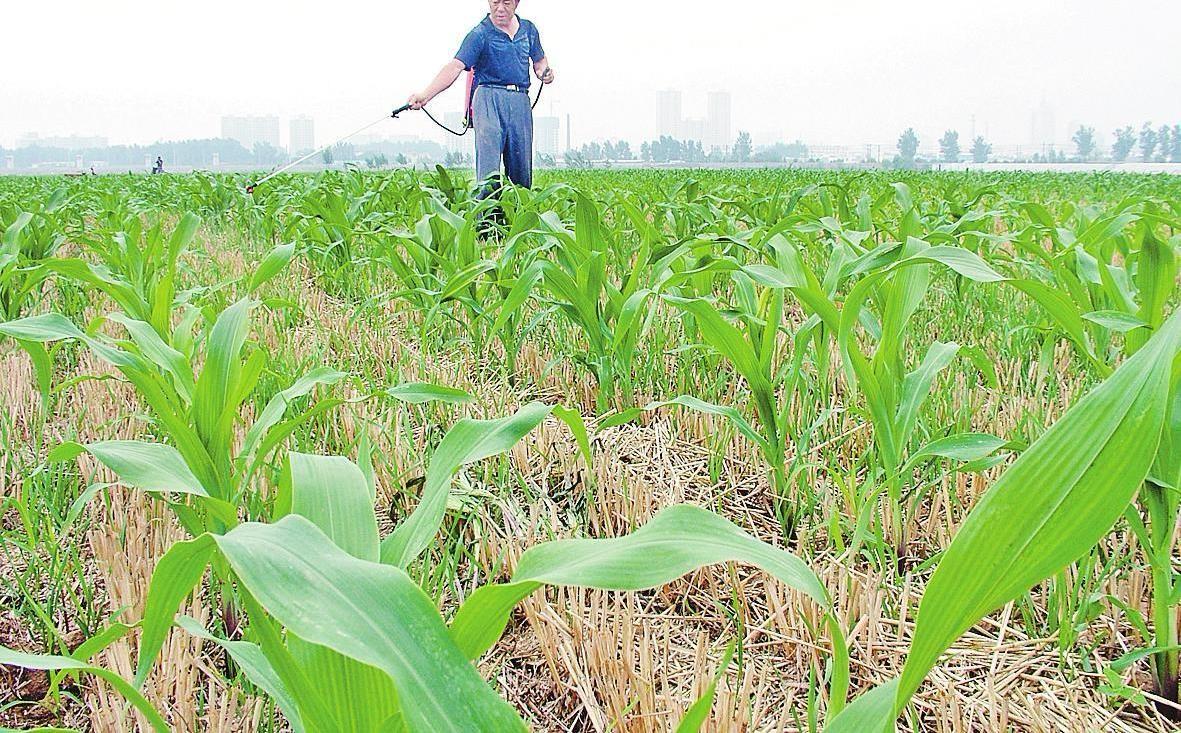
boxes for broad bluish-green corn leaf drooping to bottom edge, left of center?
[213,516,524,731]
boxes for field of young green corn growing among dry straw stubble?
[0,169,1181,733]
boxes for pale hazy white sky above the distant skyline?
[0,0,1181,146]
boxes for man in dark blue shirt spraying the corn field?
[406,0,554,196]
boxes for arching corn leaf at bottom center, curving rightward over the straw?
[451,505,829,659]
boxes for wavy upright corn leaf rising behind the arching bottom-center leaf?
[381,403,550,568]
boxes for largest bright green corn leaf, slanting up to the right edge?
[829,313,1181,732]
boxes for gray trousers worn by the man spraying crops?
[471,86,533,198]
